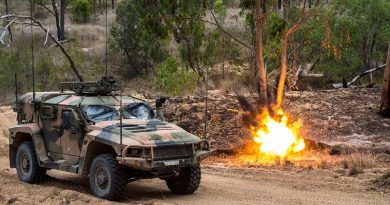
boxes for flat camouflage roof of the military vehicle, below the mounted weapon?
[18,91,145,106]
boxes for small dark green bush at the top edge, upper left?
[72,0,92,23]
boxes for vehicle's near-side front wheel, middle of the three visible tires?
[89,154,128,200]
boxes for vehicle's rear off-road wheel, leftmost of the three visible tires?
[15,141,46,184]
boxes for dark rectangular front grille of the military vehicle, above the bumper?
[153,145,193,160]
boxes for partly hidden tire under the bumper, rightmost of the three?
[165,163,201,195]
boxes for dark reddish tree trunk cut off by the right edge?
[379,44,390,117]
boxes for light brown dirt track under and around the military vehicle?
[0,107,390,205]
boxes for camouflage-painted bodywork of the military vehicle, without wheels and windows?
[10,92,209,174]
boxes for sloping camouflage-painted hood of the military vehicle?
[87,119,201,146]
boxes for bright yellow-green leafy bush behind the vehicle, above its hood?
[157,57,200,96]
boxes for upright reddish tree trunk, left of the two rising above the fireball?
[255,0,268,106]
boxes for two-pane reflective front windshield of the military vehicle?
[82,103,154,122]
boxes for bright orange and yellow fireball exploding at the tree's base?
[252,110,305,157]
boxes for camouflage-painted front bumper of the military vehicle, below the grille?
[117,150,210,171]
